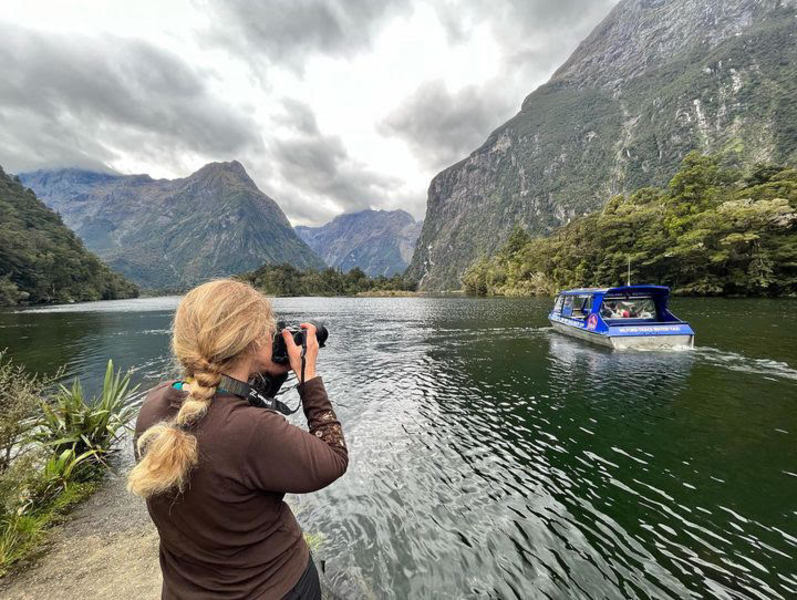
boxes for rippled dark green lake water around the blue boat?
[0,298,797,599]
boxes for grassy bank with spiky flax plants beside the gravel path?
[0,353,134,576]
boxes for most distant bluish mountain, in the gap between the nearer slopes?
[296,210,422,277]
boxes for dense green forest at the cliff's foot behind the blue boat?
[463,152,797,296]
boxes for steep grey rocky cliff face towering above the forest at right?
[408,0,797,289]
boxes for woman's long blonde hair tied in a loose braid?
[127,279,274,498]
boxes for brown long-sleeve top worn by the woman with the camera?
[135,377,349,600]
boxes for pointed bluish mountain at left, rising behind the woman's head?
[20,161,324,288]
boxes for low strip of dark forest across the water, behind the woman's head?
[239,264,416,296]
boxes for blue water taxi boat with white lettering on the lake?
[548,285,695,350]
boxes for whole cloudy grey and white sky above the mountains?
[0,0,616,225]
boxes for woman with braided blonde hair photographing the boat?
[128,280,348,600]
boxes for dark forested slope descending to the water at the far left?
[0,168,138,306]
